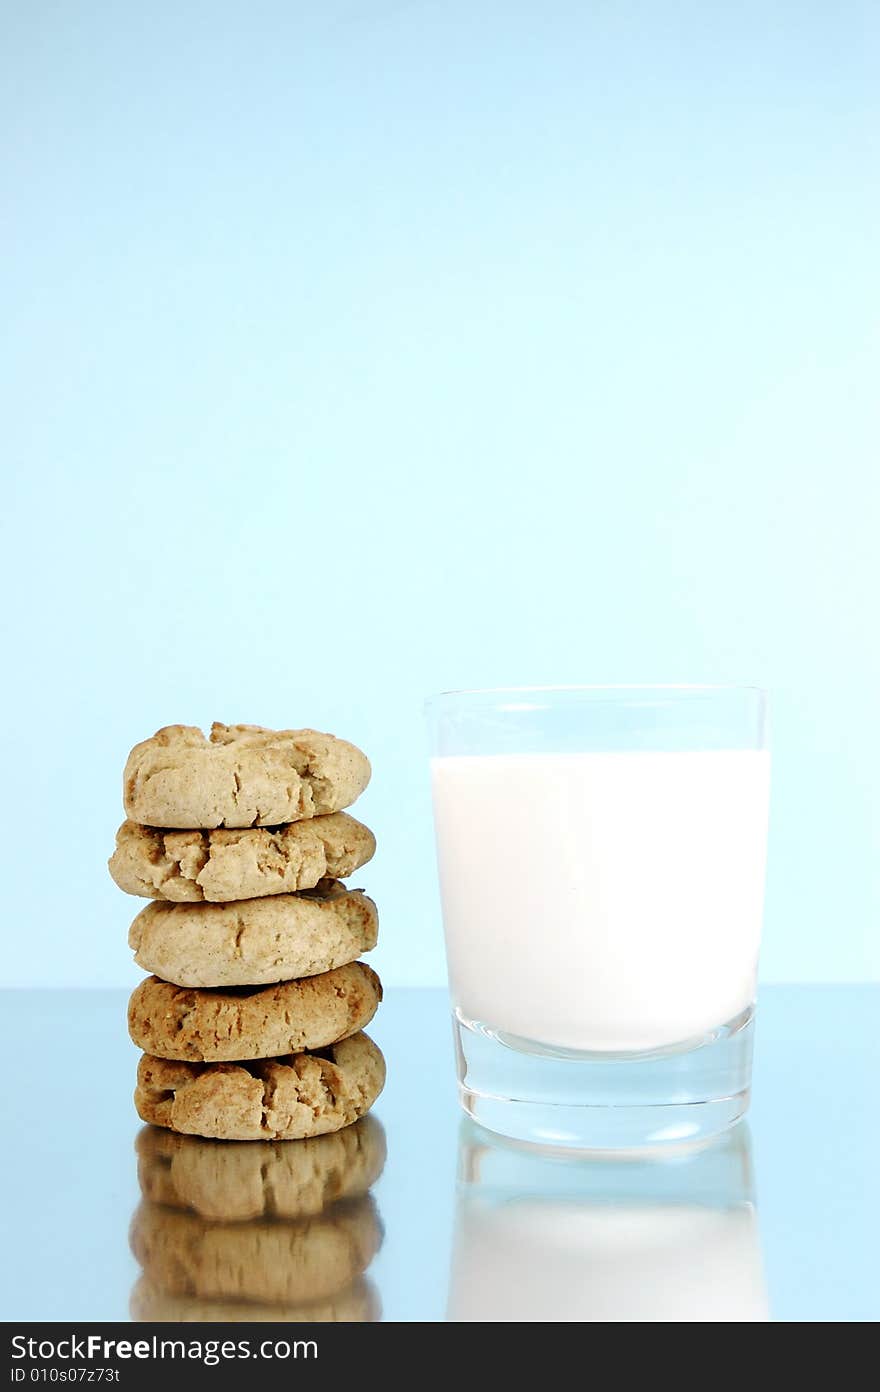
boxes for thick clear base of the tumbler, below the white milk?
[453,1005,755,1151]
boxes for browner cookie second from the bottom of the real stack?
[128,962,382,1063]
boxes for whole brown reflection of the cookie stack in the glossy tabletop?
[131,1116,386,1322]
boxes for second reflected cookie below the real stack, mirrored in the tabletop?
[129,1196,382,1304]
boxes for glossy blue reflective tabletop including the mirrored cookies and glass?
[0,987,880,1322]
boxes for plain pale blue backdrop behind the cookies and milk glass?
[0,0,880,986]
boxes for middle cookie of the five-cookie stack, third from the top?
[128,880,379,986]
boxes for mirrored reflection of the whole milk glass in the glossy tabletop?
[447,1122,769,1322]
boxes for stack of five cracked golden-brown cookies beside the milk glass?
[110,724,384,1140]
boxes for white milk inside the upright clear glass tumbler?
[432,750,770,1051]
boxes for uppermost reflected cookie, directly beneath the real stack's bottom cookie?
[135,1116,386,1222]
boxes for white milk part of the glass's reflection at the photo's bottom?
[447,1197,769,1324]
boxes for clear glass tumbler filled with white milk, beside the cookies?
[427,686,770,1150]
